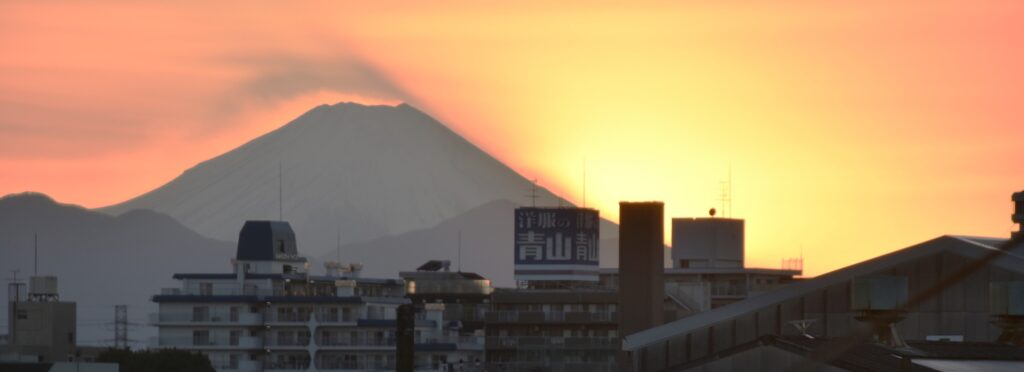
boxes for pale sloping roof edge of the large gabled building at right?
[623,236,1024,352]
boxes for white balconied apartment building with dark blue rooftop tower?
[151,221,483,372]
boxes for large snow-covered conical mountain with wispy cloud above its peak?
[102,102,573,256]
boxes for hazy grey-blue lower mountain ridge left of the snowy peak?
[0,193,232,344]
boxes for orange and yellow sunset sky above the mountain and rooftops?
[0,1,1024,275]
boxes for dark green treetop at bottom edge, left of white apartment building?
[96,348,216,372]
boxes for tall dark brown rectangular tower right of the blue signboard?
[618,202,665,371]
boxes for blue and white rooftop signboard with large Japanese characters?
[515,208,600,281]
